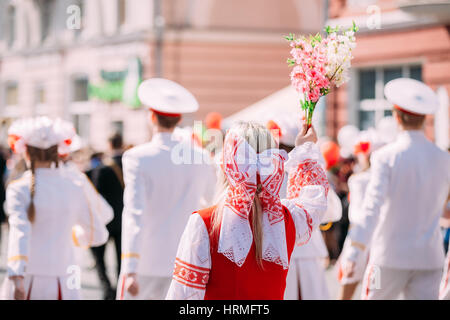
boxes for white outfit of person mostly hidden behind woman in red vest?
[280,179,342,300]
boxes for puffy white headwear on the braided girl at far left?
[8,117,64,153]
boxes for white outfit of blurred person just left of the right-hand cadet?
[336,170,370,285]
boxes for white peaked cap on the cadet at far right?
[384,78,439,115]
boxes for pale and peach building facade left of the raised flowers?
[0,0,326,150]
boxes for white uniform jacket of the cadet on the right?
[347,131,450,270]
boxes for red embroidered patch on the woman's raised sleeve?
[287,160,330,199]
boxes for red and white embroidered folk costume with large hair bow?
[167,130,329,300]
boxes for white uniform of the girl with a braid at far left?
[1,168,112,300]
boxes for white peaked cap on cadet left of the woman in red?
[138,78,198,114]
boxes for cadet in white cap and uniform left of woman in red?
[117,78,215,299]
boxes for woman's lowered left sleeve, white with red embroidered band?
[166,213,211,300]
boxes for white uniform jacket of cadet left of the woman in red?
[121,133,215,277]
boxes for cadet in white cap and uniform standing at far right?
[343,78,450,299]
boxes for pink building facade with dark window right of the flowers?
[326,0,450,149]
